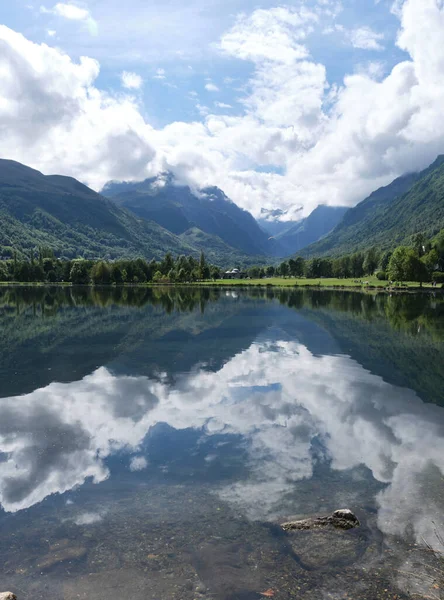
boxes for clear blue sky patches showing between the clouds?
[0,0,403,126]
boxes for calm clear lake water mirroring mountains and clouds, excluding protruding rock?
[0,288,444,600]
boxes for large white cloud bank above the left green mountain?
[0,26,155,188]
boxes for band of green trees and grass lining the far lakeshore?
[0,231,444,287]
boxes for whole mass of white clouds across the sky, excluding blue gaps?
[0,0,444,219]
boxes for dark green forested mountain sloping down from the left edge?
[0,159,264,264]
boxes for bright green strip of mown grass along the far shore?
[201,277,440,289]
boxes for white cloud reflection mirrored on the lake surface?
[0,339,444,543]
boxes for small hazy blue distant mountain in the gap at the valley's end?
[276,205,348,254]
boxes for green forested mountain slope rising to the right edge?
[301,156,444,256]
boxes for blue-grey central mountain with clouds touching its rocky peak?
[102,174,279,256]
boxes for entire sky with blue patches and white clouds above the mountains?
[0,0,444,220]
